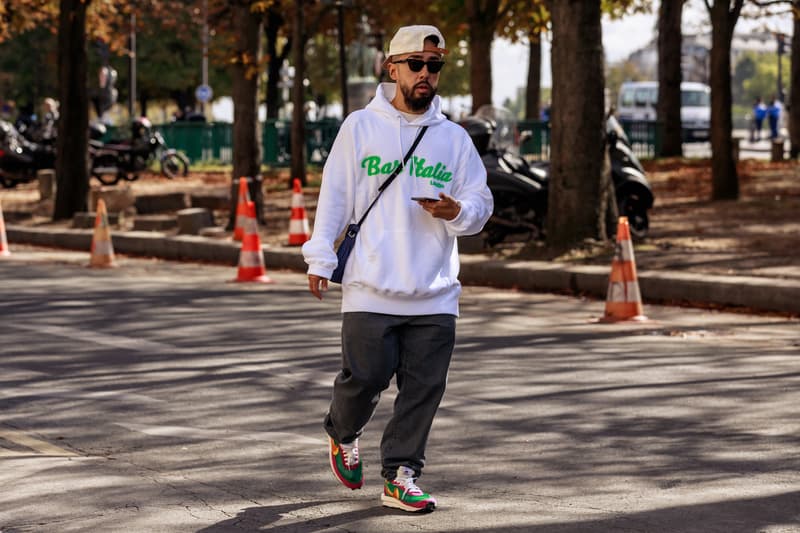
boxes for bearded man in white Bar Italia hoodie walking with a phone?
[303,26,492,512]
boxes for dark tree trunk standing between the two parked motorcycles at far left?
[53,0,89,220]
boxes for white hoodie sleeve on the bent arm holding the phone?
[445,131,494,236]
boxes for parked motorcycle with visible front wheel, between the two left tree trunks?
[89,117,189,185]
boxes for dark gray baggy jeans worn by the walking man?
[324,313,456,479]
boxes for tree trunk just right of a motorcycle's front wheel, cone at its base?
[228,0,264,227]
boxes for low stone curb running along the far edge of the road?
[6,226,800,314]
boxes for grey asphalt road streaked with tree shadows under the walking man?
[0,250,800,533]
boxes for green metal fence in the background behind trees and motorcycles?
[103,119,661,167]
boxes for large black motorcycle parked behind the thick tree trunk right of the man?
[461,106,653,247]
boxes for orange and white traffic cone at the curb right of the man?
[602,217,647,322]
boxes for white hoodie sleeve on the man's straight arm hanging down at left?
[302,115,357,279]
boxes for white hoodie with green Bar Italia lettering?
[303,83,492,315]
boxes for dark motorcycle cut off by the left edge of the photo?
[0,120,56,189]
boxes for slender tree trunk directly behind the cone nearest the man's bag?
[289,1,306,188]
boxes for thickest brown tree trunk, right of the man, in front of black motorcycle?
[547,0,606,249]
